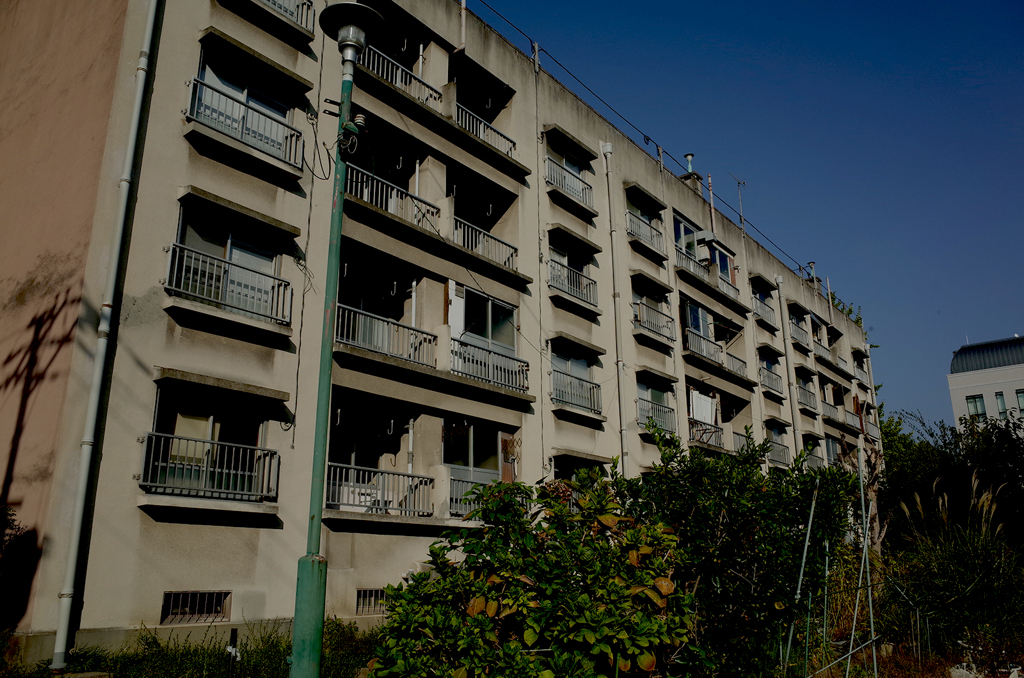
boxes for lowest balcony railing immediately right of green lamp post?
[324,463,434,516]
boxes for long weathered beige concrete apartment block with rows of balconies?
[0,0,880,656]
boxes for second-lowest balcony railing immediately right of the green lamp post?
[335,304,437,368]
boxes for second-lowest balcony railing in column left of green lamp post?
[164,243,292,325]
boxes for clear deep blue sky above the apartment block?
[468,0,1024,421]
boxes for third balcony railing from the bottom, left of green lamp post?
[188,78,302,168]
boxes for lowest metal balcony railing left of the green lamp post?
[138,433,281,502]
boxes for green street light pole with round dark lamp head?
[291,1,382,678]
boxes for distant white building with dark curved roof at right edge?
[946,335,1024,425]
